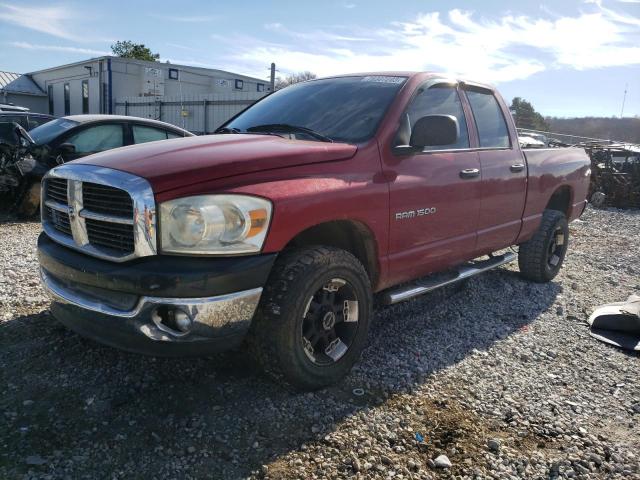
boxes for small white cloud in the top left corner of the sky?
[0,3,77,40]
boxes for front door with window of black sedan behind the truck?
[58,122,125,162]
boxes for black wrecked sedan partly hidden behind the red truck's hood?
[0,115,193,217]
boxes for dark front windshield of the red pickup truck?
[222,76,406,143]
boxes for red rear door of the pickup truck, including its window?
[465,86,527,253]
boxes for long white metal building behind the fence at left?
[28,56,270,116]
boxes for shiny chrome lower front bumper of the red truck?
[40,269,262,343]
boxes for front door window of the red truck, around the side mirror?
[394,85,469,151]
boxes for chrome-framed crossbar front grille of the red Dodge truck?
[42,165,156,261]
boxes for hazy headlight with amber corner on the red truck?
[160,195,271,254]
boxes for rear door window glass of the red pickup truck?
[467,90,510,148]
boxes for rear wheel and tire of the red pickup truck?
[518,210,569,283]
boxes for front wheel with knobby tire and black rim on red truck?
[248,247,373,390]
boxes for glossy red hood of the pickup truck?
[75,134,357,193]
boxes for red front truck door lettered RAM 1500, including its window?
[384,83,480,282]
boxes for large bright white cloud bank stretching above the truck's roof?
[221,3,640,83]
